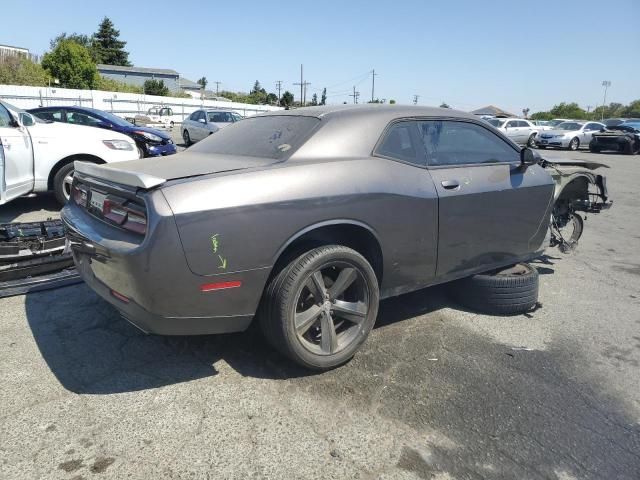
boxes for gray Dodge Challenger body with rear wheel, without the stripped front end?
[62,105,554,369]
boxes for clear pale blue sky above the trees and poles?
[5,0,640,114]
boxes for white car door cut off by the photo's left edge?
[0,104,34,203]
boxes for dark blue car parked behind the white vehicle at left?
[29,106,176,158]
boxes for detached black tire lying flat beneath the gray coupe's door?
[451,263,538,315]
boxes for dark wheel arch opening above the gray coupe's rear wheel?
[270,219,383,285]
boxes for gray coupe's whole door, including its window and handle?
[418,120,554,277]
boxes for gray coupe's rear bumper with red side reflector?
[61,198,270,335]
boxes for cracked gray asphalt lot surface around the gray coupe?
[0,151,640,480]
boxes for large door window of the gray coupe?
[418,120,520,166]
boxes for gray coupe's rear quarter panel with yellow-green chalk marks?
[162,157,437,288]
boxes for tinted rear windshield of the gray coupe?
[190,115,320,160]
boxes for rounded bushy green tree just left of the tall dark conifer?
[42,40,98,89]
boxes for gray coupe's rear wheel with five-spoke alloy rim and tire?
[260,245,379,370]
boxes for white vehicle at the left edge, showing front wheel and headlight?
[0,101,138,205]
